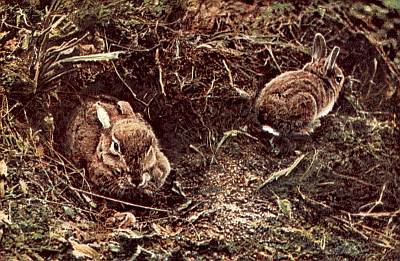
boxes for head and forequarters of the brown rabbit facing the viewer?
[88,101,171,195]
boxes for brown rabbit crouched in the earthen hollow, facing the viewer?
[66,98,171,198]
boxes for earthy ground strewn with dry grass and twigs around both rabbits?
[0,0,400,260]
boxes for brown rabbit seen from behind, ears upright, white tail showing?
[255,33,344,136]
